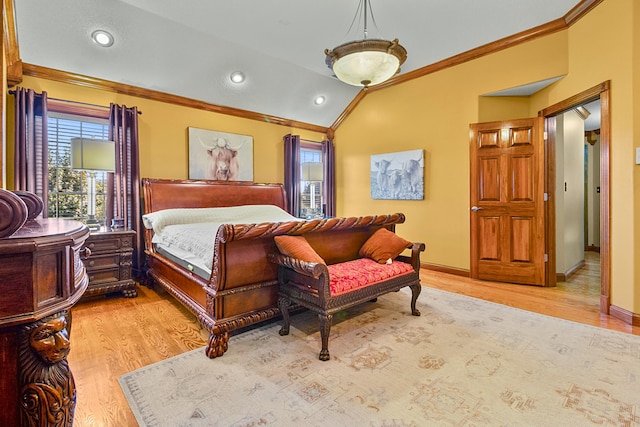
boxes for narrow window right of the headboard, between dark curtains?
[299,141,326,219]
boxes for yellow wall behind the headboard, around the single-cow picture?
[7,76,326,188]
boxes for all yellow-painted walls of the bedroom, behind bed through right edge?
[7,0,640,313]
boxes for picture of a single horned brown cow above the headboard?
[188,127,253,181]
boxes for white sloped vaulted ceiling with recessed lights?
[14,0,580,127]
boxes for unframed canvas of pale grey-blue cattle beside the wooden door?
[370,150,424,200]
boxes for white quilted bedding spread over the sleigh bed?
[142,205,302,274]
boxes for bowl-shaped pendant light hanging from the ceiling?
[324,0,407,89]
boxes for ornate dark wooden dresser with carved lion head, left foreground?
[0,189,89,426]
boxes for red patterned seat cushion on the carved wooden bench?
[327,258,414,295]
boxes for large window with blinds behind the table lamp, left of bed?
[47,103,109,224]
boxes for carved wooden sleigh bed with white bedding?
[142,178,405,358]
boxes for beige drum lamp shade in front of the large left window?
[71,138,116,172]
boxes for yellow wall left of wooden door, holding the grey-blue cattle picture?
[334,32,568,270]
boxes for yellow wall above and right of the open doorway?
[532,0,640,313]
